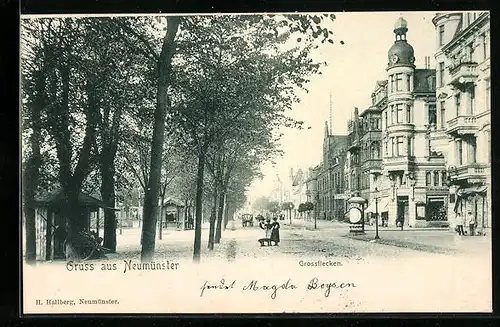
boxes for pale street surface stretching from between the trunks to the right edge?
[111,219,490,261]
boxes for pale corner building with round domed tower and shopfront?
[378,18,448,227]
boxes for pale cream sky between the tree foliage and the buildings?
[247,12,436,202]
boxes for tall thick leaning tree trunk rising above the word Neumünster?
[141,16,180,261]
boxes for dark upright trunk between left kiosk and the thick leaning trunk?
[101,156,116,252]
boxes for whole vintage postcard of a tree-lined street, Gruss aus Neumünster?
[20,11,492,315]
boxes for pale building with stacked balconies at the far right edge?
[433,12,491,228]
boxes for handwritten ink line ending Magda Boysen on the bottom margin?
[200,277,356,300]
